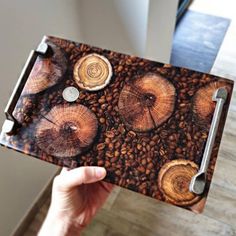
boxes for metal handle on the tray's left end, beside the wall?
[2,42,49,134]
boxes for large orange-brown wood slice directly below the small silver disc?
[36,104,98,157]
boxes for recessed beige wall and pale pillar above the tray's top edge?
[76,0,178,63]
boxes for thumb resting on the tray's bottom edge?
[54,166,106,190]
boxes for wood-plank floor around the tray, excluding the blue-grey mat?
[19,0,236,236]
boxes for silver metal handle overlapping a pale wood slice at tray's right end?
[189,88,228,194]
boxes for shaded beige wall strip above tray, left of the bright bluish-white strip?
[78,0,134,55]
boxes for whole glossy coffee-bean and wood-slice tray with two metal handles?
[0,37,233,212]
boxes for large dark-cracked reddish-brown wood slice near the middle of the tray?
[118,74,176,132]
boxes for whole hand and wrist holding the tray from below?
[38,167,113,236]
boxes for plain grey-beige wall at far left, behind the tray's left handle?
[0,0,83,236]
